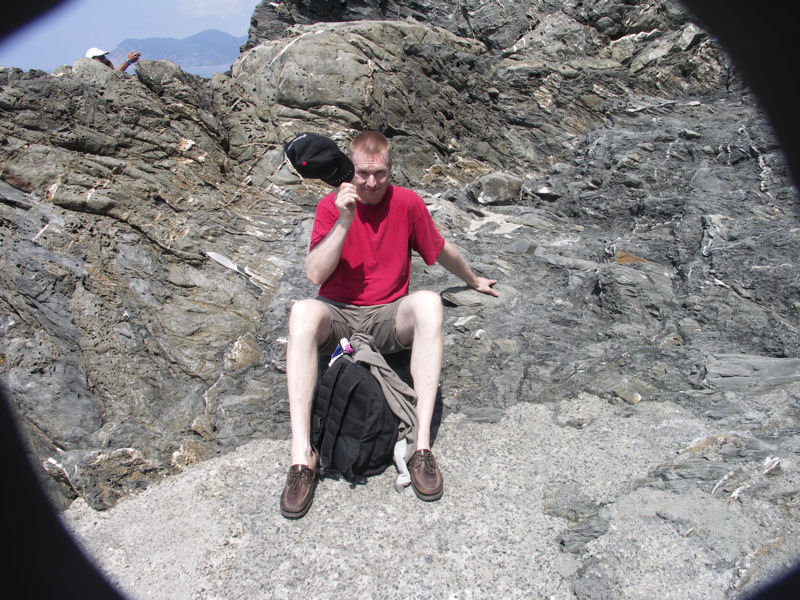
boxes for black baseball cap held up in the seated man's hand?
[284,133,355,187]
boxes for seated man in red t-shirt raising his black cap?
[280,131,497,518]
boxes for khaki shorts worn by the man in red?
[317,297,408,354]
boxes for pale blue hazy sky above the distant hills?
[0,0,259,71]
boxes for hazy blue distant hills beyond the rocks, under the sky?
[110,29,247,77]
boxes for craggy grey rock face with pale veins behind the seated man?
[0,0,800,548]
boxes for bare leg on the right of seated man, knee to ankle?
[395,291,444,450]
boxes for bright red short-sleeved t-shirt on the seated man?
[311,185,444,306]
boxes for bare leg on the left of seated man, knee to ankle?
[286,298,331,465]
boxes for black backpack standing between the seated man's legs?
[311,354,400,483]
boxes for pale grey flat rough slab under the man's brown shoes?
[63,394,800,600]
